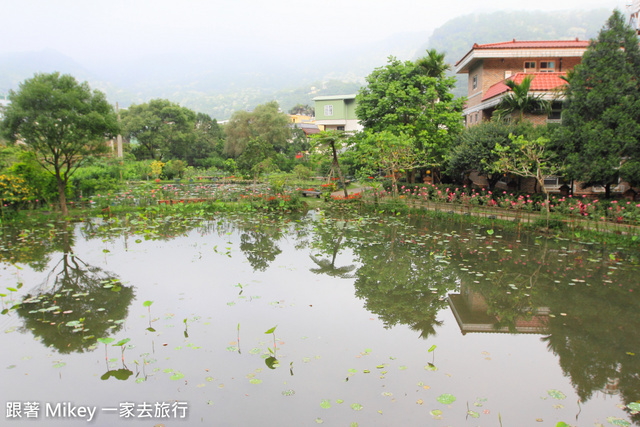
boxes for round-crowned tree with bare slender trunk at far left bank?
[2,72,118,215]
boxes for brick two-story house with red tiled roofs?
[455,39,589,126]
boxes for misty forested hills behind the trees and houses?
[0,9,611,120]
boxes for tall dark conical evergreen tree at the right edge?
[559,10,640,196]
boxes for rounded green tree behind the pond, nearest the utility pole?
[122,99,196,160]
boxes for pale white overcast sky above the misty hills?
[0,0,624,62]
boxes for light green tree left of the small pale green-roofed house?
[224,101,291,158]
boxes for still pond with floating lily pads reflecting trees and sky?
[0,210,640,426]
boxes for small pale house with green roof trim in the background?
[313,94,363,132]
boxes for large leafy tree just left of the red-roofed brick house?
[356,51,464,179]
